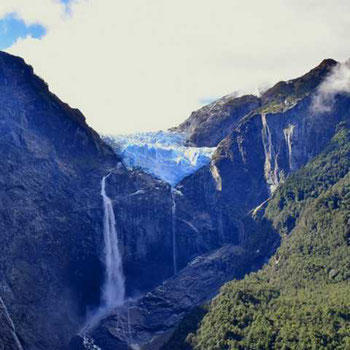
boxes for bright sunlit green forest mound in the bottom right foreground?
[193,282,350,350]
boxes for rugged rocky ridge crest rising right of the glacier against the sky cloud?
[175,59,337,147]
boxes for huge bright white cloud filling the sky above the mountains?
[5,0,350,133]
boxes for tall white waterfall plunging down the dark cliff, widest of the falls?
[101,174,125,310]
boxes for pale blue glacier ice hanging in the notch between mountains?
[103,131,215,186]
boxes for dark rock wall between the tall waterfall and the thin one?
[101,167,174,297]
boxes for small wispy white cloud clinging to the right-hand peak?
[312,60,350,113]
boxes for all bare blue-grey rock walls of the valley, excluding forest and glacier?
[0,54,350,349]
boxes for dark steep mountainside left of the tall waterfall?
[0,53,118,349]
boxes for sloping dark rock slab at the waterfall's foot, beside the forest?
[70,245,274,350]
